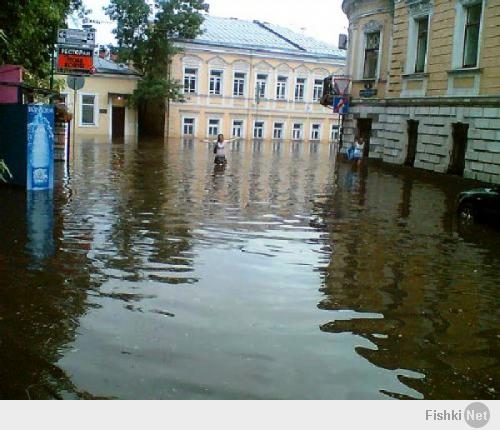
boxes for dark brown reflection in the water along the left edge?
[0,190,107,399]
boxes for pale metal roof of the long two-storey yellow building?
[181,15,346,60]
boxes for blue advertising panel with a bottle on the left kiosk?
[27,105,54,190]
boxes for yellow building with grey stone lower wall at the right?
[342,0,500,183]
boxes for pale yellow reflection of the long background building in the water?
[170,140,335,222]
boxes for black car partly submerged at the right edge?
[457,186,500,225]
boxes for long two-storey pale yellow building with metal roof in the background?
[167,16,345,142]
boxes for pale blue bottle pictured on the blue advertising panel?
[31,111,50,188]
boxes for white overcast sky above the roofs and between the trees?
[81,0,348,45]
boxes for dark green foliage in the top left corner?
[0,0,84,82]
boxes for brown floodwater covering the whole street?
[0,141,500,399]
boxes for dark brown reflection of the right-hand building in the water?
[310,160,500,399]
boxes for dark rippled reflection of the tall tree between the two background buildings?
[99,146,195,284]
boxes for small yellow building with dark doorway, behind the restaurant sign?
[56,57,139,140]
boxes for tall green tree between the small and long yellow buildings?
[105,0,207,105]
